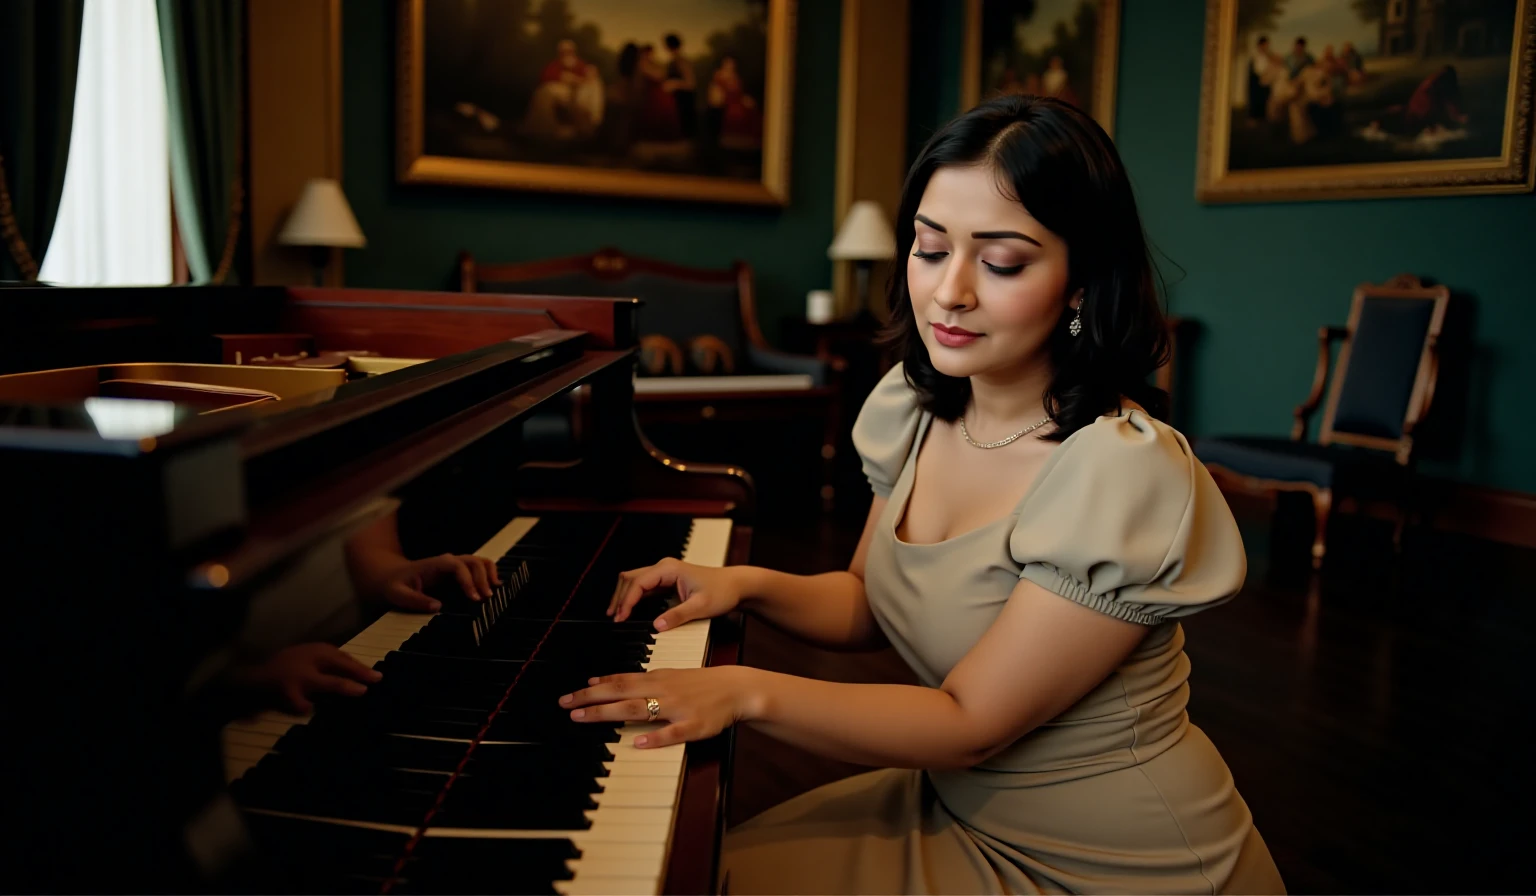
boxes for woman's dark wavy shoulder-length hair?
[882,95,1169,441]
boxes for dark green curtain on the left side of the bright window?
[0,0,84,280]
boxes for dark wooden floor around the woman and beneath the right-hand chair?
[731,506,1536,893]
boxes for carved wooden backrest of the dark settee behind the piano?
[459,247,766,370]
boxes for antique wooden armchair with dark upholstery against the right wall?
[1195,274,1450,569]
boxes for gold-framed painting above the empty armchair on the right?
[1195,0,1536,201]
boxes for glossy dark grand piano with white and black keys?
[0,287,753,893]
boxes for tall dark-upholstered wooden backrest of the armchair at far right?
[1318,275,1450,463]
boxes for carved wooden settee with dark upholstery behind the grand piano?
[458,247,845,509]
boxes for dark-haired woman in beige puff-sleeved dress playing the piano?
[562,97,1284,893]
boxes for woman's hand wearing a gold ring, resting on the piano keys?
[561,665,759,748]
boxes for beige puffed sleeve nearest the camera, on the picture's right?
[1009,410,1247,626]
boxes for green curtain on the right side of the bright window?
[155,0,244,283]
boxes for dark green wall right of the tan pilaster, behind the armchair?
[912,0,1536,492]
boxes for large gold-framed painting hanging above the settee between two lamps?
[395,0,796,204]
